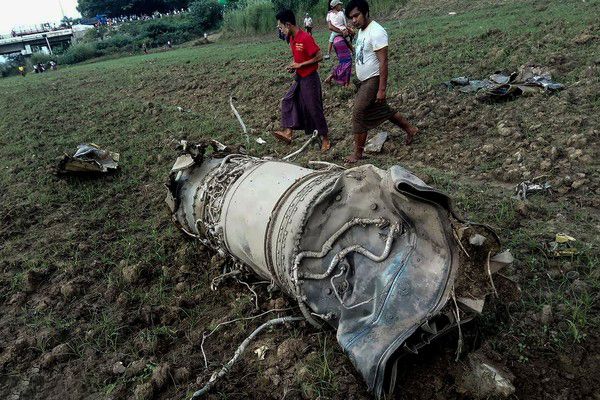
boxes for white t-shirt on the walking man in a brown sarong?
[356,21,388,81]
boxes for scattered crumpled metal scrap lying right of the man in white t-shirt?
[446,66,564,100]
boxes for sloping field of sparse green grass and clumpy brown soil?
[0,0,600,399]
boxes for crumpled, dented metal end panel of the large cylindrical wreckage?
[292,165,458,396]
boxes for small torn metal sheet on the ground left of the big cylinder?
[57,143,120,174]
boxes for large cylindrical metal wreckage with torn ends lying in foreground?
[167,142,512,398]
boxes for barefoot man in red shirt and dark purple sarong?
[273,10,331,151]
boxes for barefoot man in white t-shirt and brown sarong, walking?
[346,0,419,163]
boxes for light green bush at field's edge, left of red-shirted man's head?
[223,0,276,35]
